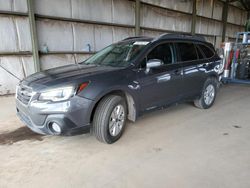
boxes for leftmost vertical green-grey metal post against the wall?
[27,0,40,72]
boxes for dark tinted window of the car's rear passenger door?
[177,42,197,61]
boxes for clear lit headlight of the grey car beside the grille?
[38,86,76,102]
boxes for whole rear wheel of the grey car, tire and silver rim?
[194,78,218,109]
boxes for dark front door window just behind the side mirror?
[147,43,174,65]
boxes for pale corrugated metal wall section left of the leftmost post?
[0,0,34,95]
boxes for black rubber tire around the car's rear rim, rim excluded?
[194,78,219,109]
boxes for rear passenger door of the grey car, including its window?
[176,42,206,97]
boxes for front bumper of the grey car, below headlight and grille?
[16,96,94,135]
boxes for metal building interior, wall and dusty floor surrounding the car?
[0,0,250,188]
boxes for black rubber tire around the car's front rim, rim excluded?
[93,95,127,144]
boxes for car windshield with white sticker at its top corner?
[83,41,149,67]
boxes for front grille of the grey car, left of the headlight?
[16,86,33,105]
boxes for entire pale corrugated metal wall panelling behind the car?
[0,0,247,95]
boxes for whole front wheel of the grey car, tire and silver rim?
[93,95,127,144]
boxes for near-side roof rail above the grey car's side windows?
[155,33,206,42]
